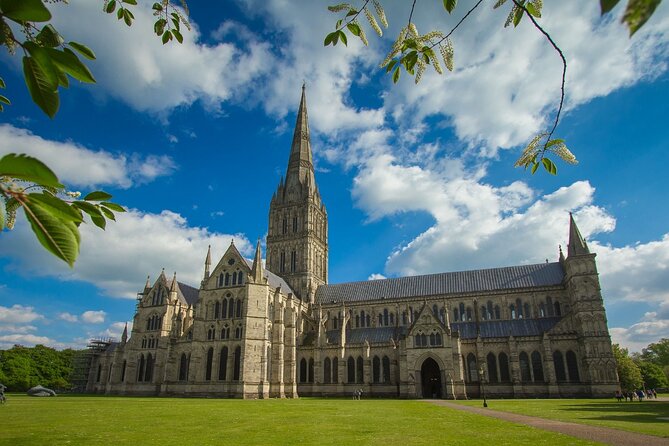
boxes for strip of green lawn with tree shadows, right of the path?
[457,398,669,437]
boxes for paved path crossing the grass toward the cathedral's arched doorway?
[427,400,669,446]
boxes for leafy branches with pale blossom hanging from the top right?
[323,0,661,175]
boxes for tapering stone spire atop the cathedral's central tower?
[286,84,316,194]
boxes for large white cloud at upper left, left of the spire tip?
[47,0,273,112]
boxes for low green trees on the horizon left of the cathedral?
[0,345,75,392]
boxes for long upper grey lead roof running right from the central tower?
[316,262,564,304]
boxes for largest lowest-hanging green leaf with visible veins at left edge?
[21,197,81,267]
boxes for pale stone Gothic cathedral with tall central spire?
[86,87,618,399]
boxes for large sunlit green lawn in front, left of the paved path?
[0,395,592,446]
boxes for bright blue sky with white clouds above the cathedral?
[0,0,669,350]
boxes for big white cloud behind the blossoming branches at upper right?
[384,1,669,156]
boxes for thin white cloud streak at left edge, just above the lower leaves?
[0,124,176,188]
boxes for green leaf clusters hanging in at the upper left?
[0,0,190,267]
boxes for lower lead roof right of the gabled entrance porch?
[451,317,562,339]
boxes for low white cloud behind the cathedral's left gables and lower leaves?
[0,210,253,298]
